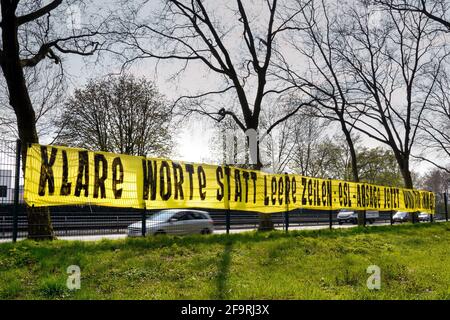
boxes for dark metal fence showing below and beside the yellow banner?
[0,140,448,241]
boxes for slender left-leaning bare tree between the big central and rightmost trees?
[277,0,359,182]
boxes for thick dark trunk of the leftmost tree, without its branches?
[1,1,53,240]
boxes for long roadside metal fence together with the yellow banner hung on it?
[0,140,448,241]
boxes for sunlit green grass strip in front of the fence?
[0,223,450,299]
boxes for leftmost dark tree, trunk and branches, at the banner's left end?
[0,0,111,239]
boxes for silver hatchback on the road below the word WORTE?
[128,209,214,237]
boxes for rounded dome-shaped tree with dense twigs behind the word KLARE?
[56,75,172,157]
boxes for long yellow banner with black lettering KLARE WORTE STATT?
[24,144,435,213]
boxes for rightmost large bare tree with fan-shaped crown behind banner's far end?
[337,2,446,188]
